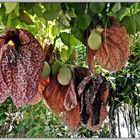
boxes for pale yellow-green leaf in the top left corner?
[4,2,18,14]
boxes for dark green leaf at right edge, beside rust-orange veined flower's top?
[121,13,140,34]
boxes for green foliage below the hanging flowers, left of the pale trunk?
[0,98,97,138]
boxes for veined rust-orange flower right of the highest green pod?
[95,17,129,71]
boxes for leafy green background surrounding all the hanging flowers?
[0,2,140,138]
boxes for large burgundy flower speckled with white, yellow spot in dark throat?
[0,29,45,107]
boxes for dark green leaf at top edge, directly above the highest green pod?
[89,2,105,13]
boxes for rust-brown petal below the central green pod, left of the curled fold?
[43,75,68,113]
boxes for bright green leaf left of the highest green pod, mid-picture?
[60,32,79,47]
